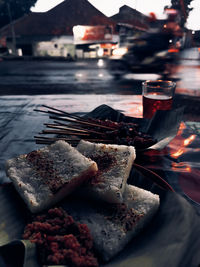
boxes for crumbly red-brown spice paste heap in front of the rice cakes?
[23,208,98,267]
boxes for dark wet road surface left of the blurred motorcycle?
[0,59,144,94]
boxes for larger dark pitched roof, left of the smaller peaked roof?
[0,0,115,36]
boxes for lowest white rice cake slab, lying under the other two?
[64,185,160,261]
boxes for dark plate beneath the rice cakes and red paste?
[0,164,200,267]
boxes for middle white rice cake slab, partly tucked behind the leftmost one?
[77,140,136,203]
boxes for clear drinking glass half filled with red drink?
[142,80,176,119]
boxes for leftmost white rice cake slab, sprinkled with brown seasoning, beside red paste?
[6,141,97,213]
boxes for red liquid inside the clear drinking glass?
[142,94,172,119]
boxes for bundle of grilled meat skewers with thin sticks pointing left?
[34,105,156,149]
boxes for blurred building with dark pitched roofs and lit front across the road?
[0,0,195,59]
